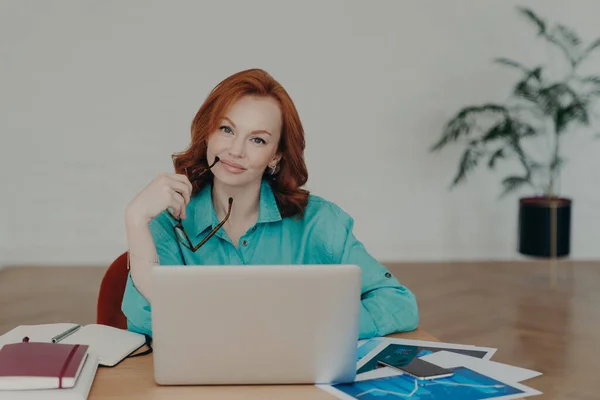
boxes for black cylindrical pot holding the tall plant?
[519,197,572,258]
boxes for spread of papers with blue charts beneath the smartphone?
[318,338,542,400]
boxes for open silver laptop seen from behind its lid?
[152,265,361,385]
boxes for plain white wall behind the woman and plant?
[0,0,600,265]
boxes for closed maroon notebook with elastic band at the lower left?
[0,342,88,390]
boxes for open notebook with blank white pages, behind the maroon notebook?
[0,323,146,367]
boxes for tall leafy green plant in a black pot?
[431,7,600,257]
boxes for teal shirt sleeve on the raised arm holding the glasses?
[121,214,183,337]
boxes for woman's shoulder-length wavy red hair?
[173,69,309,217]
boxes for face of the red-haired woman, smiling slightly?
[206,96,282,186]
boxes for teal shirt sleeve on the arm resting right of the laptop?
[330,211,419,339]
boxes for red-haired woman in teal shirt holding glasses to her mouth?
[122,69,418,339]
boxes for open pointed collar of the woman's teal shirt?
[189,179,281,236]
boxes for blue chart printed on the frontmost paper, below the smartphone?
[333,367,523,400]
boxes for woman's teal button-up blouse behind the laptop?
[122,180,419,339]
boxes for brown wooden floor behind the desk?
[0,262,600,400]
